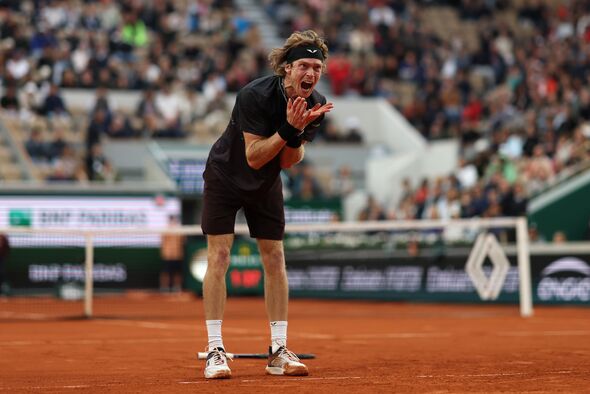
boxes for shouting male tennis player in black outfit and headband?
[201,30,333,379]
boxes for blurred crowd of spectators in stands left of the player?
[0,0,266,181]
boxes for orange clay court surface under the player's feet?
[0,293,590,394]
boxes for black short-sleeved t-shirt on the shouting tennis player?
[206,75,326,193]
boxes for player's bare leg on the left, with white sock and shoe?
[203,234,234,379]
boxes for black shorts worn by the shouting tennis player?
[201,169,285,240]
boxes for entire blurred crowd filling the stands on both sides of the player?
[0,0,590,237]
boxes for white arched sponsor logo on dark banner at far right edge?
[537,257,590,302]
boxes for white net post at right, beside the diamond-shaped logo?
[516,217,533,317]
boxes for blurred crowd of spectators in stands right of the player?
[260,0,590,219]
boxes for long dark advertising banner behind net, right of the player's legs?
[287,253,590,306]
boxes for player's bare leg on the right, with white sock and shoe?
[258,239,308,376]
